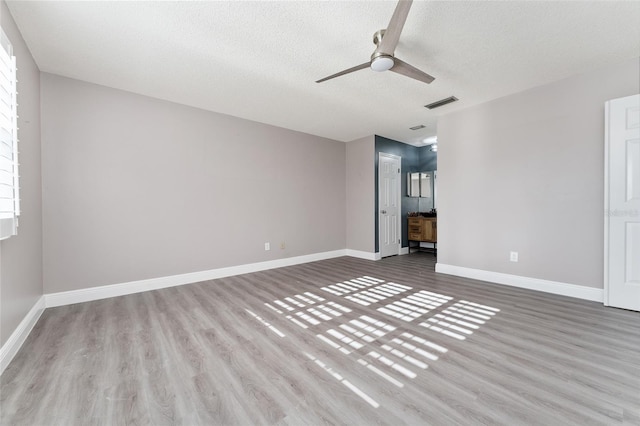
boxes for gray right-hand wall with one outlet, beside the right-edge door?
[438,59,640,288]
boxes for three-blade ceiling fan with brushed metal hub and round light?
[316,0,435,84]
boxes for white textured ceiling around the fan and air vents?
[7,1,640,144]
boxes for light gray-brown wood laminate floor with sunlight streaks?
[0,253,640,426]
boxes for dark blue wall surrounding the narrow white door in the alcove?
[374,135,438,252]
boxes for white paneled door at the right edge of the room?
[604,95,640,311]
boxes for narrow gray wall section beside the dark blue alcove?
[346,136,376,253]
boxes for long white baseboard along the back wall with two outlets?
[44,250,350,308]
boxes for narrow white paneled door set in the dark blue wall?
[378,152,400,257]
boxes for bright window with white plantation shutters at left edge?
[0,29,20,240]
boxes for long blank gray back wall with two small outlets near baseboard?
[41,73,346,293]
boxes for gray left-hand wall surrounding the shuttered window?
[0,1,42,345]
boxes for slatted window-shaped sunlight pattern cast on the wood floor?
[247,276,500,407]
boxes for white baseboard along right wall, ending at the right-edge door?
[436,263,604,302]
